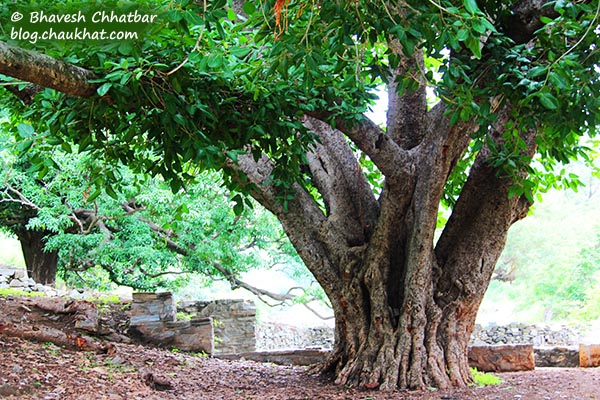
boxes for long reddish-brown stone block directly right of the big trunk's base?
[469,344,535,372]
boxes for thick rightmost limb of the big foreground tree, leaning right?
[435,106,536,306]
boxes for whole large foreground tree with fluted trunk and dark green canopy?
[0,0,600,389]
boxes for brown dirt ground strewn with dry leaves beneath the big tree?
[0,298,600,400]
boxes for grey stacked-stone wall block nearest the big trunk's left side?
[177,300,256,354]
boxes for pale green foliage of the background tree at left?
[0,125,295,289]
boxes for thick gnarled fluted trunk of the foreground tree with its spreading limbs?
[233,98,535,389]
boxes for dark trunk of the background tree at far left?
[17,229,58,285]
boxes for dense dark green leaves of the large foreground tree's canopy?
[2,0,600,205]
